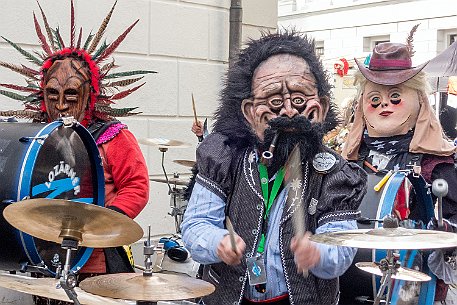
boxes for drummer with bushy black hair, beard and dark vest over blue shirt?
[182,31,366,305]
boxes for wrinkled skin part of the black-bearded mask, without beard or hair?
[241,54,329,141]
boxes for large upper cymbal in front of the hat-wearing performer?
[310,228,457,249]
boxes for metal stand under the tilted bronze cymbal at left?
[59,238,81,305]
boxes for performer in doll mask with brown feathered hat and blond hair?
[342,26,457,304]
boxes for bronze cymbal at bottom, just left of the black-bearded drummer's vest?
[79,273,214,302]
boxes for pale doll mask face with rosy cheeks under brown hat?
[362,81,420,137]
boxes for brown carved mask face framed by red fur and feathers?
[43,58,90,122]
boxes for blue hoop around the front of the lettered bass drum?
[17,120,105,276]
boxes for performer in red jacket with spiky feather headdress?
[0,2,152,304]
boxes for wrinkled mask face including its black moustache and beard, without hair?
[241,54,329,167]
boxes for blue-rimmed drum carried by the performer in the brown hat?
[339,172,436,305]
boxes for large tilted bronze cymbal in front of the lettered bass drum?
[3,198,143,248]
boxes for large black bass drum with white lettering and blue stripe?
[0,121,105,276]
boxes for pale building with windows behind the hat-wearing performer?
[278,0,457,104]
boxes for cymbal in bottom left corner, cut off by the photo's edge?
[0,274,129,305]
